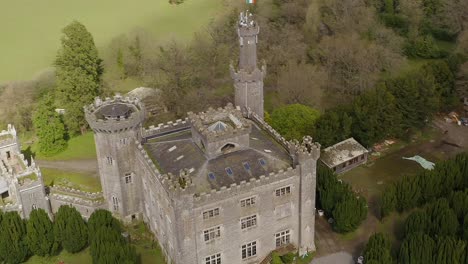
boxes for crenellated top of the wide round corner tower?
[84,94,146,133]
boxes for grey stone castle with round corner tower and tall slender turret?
[85,10,320,264]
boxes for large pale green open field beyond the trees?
[0,0,223,83]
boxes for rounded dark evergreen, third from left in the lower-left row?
[54,205,88,253]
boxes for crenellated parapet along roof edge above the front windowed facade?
[194,167,299,204]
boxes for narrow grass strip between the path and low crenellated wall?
[41,168,102,192]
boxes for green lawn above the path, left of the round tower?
[27,132,96,161]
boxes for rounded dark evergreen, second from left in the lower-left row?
[26,209,58,257]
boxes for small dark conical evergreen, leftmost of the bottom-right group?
[364,233,393,264]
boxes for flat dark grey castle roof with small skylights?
[145,119,292,192]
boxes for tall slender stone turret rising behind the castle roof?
[231,11,266,119]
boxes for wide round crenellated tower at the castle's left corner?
[85,95,145,221]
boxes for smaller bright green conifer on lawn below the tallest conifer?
[33,94,67,155]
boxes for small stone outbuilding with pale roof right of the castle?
[320,138,369,173]
